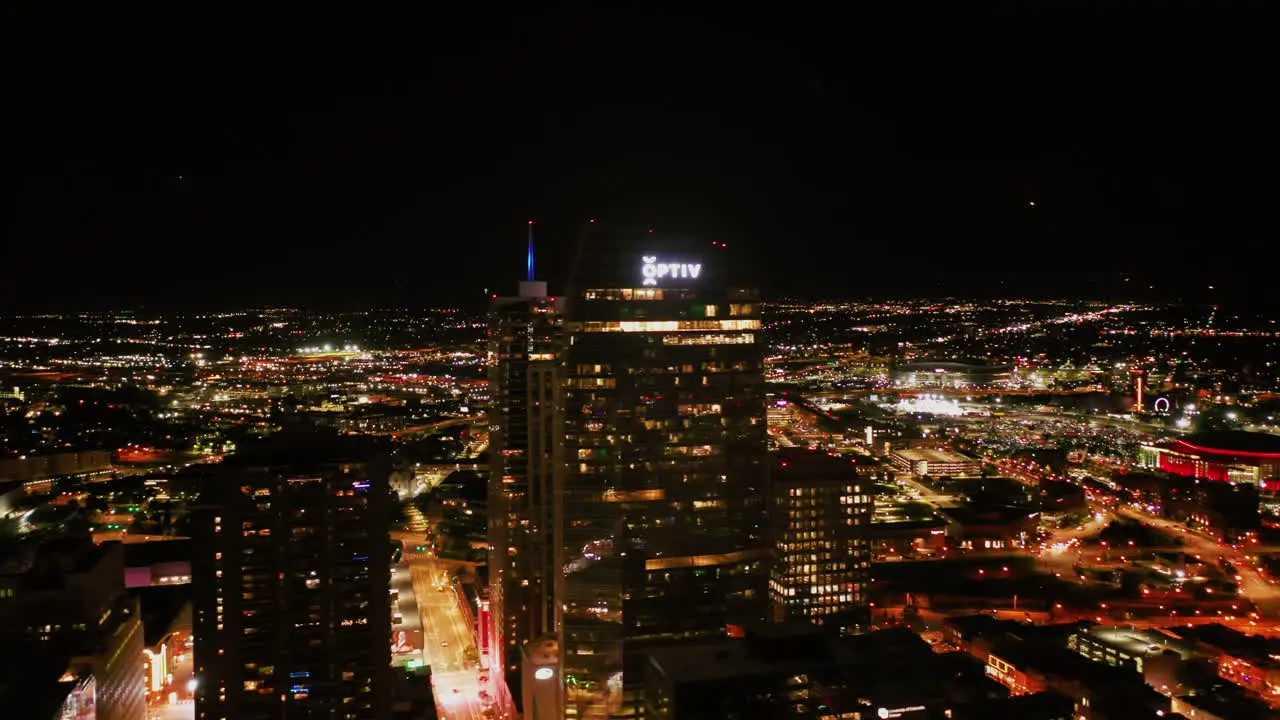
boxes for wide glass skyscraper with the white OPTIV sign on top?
[557,236,768,717]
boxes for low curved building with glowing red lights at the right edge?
[1139,430,1280,491]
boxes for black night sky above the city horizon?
[0,0,1280,307]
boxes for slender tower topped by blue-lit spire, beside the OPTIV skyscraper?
[488,271,563,697]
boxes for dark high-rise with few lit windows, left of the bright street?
[192,438,390,720]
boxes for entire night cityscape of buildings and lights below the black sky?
[0,293,1280,720]
